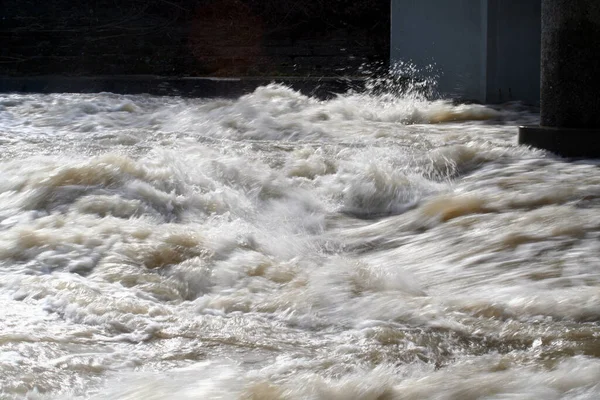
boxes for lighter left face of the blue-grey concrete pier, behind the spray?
[391,0,487,99]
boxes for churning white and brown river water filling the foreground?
[0,85,600,400]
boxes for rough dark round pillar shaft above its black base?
[541,0,600,127]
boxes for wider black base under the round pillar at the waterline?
[519,125,600,158]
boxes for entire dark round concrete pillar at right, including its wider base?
[519,0,600,157]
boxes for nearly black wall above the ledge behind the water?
[0,0,390,76]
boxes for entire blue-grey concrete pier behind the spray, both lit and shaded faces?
[390,0,541,104]
